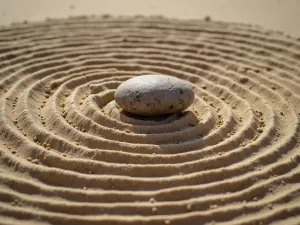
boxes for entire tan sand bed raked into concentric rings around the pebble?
[0,16,300,225]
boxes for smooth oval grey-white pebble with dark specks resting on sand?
[115,75,194,116]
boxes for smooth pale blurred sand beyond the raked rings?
[0,0,300,37]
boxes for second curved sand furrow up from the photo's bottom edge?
[0,185,299,219]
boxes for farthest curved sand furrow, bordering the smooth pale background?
[3,18,297,52]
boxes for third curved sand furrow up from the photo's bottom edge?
[2,162,299,203]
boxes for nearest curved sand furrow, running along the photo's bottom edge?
[0,199,300,224]
